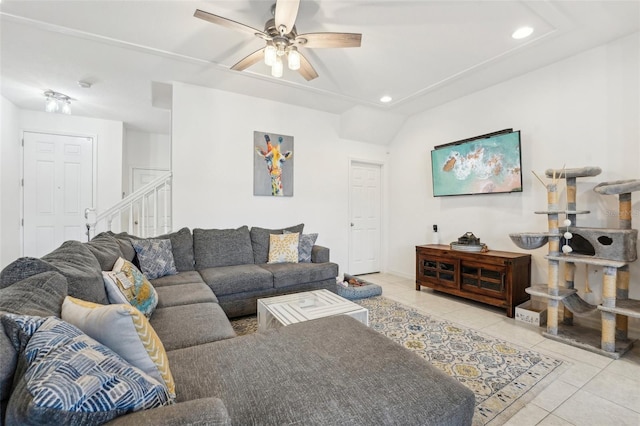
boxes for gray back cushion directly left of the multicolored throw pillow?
[42,241,109,305]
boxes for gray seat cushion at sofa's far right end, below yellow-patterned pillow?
[260,262,338,288]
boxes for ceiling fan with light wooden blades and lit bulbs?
[193,0,362,81]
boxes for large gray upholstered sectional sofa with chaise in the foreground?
[0,225,474,425]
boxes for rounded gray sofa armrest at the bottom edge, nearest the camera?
[106,398,231,426]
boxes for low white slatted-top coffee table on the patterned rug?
[258,290,369,332]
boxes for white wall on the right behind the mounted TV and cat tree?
[388,34,640,299]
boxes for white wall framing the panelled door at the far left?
[0,106,123,267]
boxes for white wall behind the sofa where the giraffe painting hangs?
[172,83,387,271]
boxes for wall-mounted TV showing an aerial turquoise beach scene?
[431,129,522,197]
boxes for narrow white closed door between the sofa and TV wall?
[347,162,382,275]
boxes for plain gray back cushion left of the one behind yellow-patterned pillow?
[193,226,253,270]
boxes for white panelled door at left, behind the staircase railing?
[23,132,93,257]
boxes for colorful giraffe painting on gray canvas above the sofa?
[253,131,293,197]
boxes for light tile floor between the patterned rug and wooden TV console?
[362,273,640,426]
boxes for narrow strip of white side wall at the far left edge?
[0,97,22,267]
